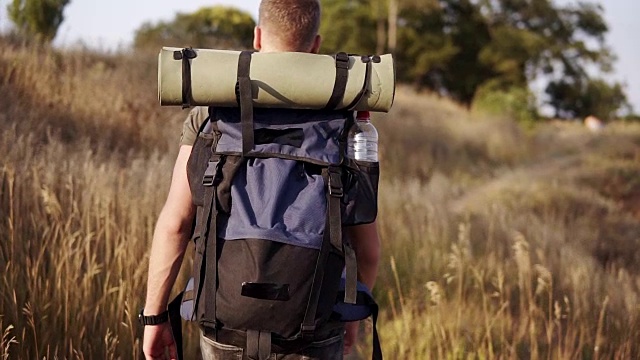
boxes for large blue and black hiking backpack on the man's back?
[180,50,382,360]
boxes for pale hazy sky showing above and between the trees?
[0,0,640,113]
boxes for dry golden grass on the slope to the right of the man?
[368,95,640,359]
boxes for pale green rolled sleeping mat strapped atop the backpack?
[158,47,395,112]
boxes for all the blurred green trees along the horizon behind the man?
[8,0,632,120]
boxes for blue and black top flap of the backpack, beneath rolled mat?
[213,108,348,165]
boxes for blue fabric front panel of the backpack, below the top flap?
[218,158,327,249]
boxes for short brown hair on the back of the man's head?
[258,0,320,51]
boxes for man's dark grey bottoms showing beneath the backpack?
[200,329,344,360]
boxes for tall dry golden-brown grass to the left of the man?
[0,39,178,359]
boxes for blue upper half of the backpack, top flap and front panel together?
[212,108,348,249]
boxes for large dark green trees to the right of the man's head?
[321,0,625,121]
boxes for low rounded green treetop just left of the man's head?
[134,6,256,49]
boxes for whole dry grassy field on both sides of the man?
[0,40,640,359]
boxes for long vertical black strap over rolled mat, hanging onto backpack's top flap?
[237,51,254,156]
